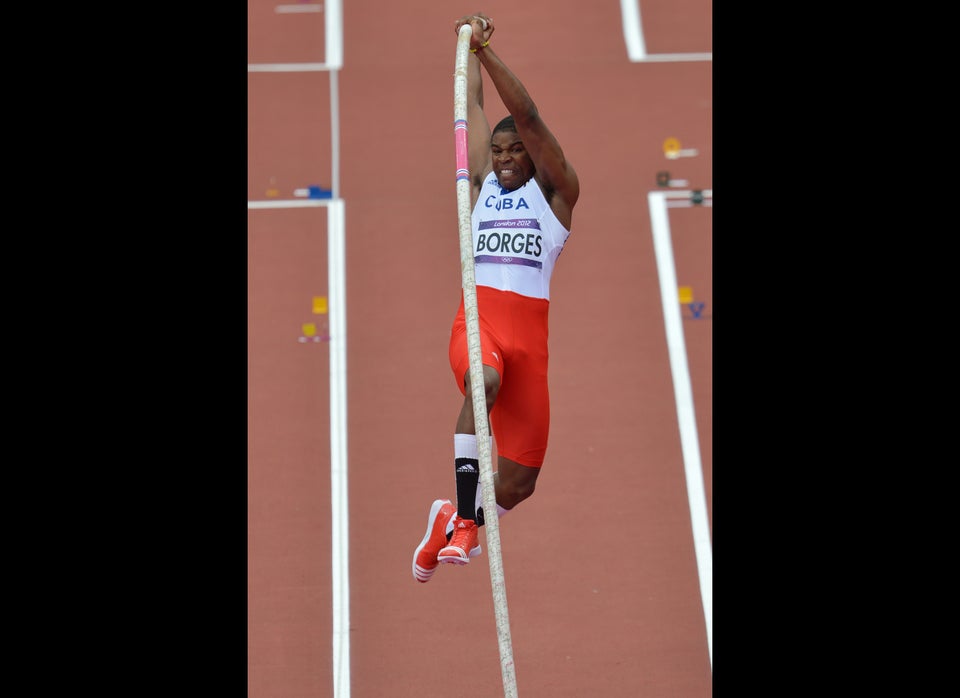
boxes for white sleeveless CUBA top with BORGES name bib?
[471,172,570,300]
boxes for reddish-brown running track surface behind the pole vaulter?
[248,0,712,698]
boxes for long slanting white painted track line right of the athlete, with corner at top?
[647,189,713,671]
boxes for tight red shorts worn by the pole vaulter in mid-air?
[450,286,550,468]
